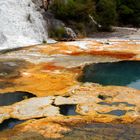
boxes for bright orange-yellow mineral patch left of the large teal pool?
[0,62,79,96]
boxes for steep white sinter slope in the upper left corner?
[0,0,47,50]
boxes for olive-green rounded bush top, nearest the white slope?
[51,0,94,22]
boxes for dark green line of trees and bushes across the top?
[50,0,140,31]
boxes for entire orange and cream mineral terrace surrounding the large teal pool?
[0,40,140,140]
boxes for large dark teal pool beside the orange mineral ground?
[80,61,140,89]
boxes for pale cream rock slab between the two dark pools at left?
[0,97,59,123]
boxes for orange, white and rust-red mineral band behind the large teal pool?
[36,41,140,59]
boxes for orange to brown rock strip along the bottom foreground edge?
[0,116,140,140]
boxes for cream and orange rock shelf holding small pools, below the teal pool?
[0,83,140,123]
